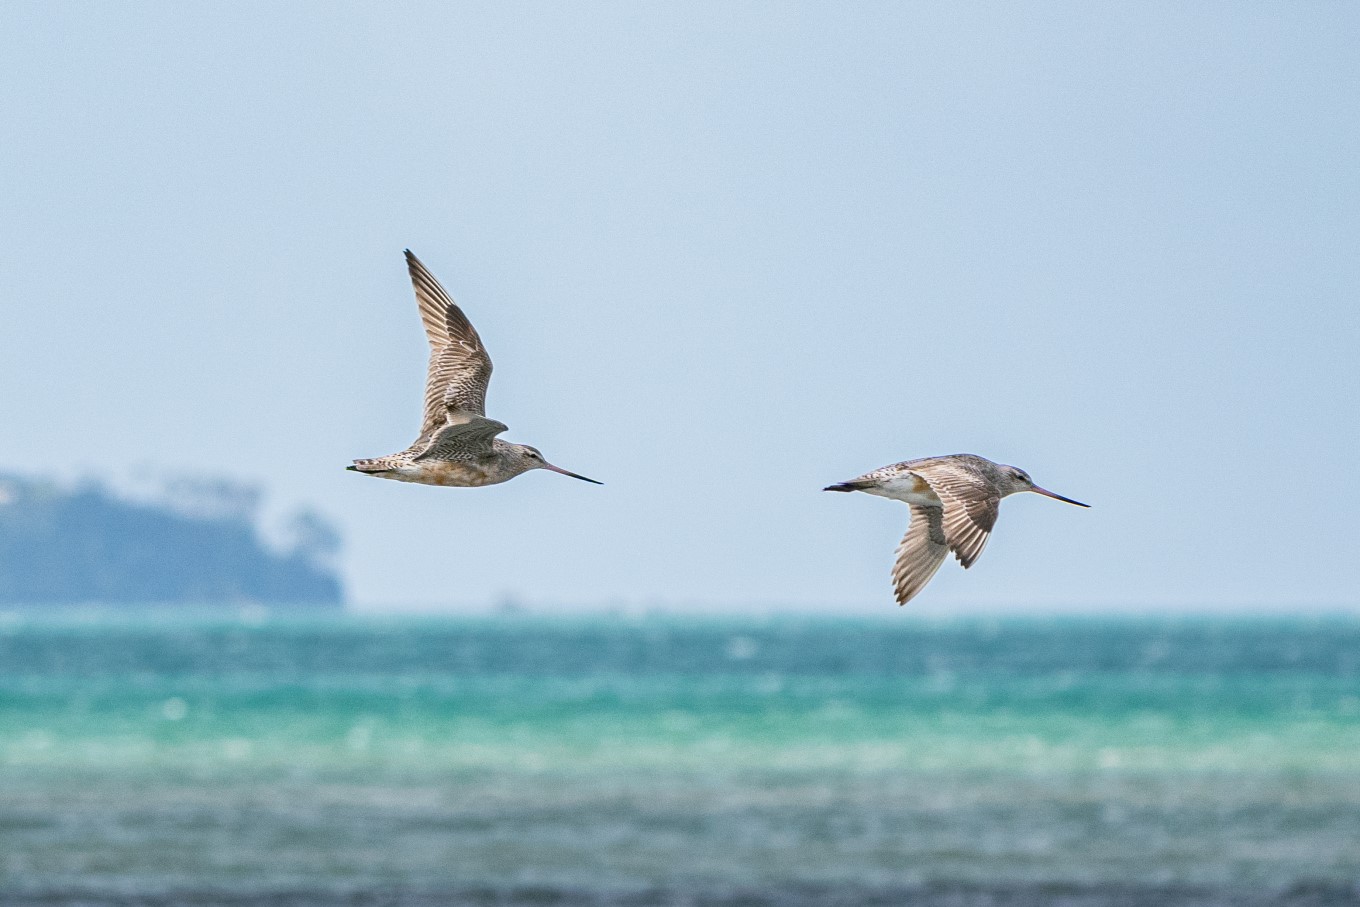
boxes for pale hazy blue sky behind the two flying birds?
[0,1,1360,612]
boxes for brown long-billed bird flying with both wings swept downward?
[823,454,1091,605]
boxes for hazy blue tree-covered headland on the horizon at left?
[0,476,344,609]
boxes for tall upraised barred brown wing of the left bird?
[407,249,503,438]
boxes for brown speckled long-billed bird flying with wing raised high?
[347,249,601,487]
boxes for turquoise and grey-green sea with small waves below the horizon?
[0,609,1360,907]
